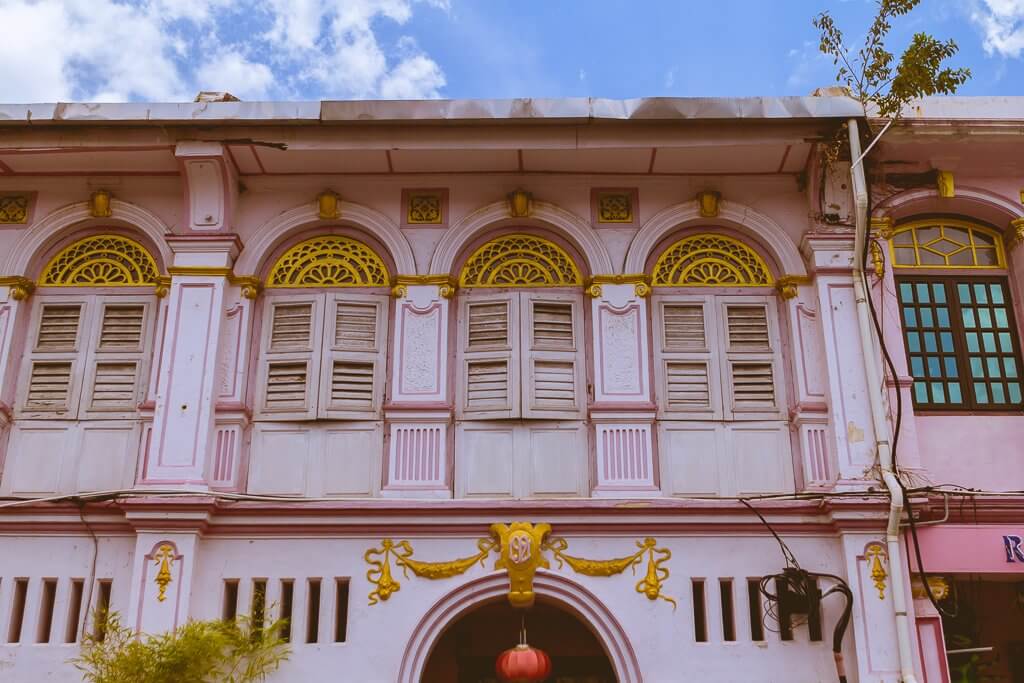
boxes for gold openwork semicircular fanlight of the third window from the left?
[459,233,583,287]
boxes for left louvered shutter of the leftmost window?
[18,297,91,418]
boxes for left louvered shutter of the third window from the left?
[458,292,521,419]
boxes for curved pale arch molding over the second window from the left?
[234,202,417,274]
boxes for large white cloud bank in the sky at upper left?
[0,0,450,101]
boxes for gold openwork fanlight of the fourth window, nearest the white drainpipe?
[653,233,773,287]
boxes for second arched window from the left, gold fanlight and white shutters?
[256,234,390,420]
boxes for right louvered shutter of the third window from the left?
[519,292,587,419]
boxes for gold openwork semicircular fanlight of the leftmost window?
[39,234,160,287]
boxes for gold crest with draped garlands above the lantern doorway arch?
[362,522,676,608]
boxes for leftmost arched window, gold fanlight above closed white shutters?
[18,233,159,420]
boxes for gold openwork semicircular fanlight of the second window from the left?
[266,234,390,288]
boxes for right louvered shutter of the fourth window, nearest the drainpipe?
[720,297,782,419]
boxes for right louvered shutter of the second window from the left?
[317,292,388,419]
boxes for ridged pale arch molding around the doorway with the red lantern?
[397,570,643,683]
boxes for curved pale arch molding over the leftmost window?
[0,199,174,276]
